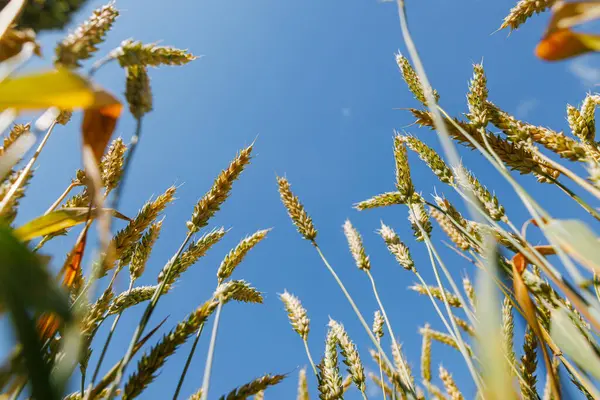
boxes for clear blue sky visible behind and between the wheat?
[4,0,600,399]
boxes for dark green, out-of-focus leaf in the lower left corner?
[0,225,72,399]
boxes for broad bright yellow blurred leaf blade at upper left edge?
[0,68,96,110]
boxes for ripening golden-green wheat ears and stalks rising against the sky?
[0,0,600,400]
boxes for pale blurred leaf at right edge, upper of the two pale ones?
[544,220,600,273]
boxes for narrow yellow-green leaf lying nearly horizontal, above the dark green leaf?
[15,207,130,241]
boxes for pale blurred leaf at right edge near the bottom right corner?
[550,308,600,379]
